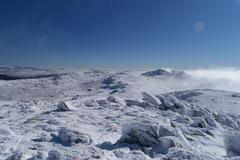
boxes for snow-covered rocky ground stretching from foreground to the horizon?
[0,68,240,160]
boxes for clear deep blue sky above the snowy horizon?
[0,0,240,68]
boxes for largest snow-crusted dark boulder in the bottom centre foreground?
[115,121,182,154]
